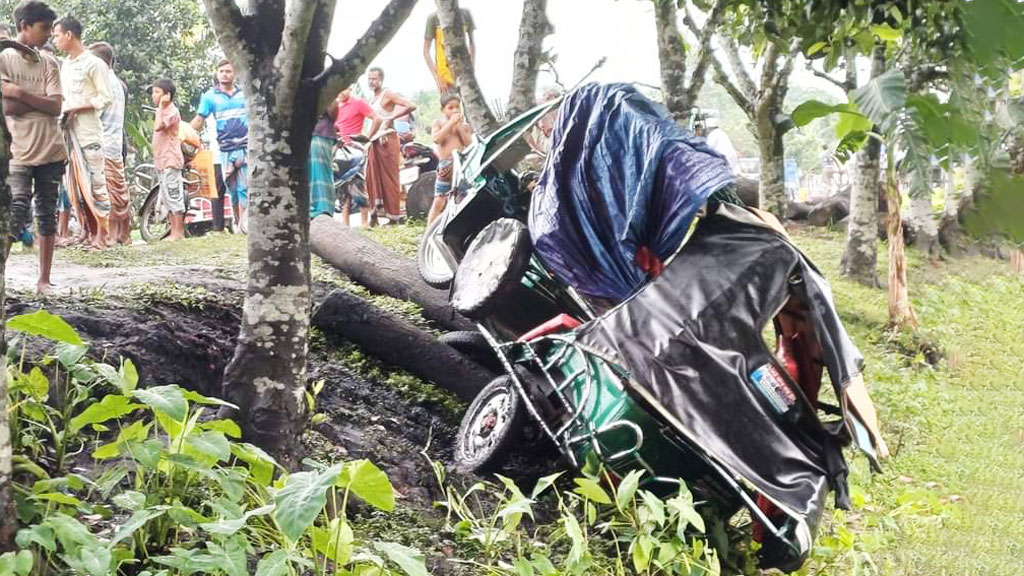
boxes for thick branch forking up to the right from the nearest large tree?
[315,0,416,111]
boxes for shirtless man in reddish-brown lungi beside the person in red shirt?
[367,67,416,224]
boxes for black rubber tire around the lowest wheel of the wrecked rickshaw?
[455,374,527,474]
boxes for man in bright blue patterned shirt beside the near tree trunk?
[191,59,249,227]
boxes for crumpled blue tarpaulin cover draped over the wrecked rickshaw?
[529,84,733,301]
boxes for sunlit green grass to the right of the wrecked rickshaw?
[795,224,1024,575]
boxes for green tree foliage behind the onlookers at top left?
[0,0,219,154]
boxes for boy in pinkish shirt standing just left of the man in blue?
[150,78,185,241]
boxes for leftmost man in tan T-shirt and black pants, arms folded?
[0,0,68,293]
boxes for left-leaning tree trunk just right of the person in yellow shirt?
[437,0,499,136]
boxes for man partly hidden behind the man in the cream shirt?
[89,42,131,245]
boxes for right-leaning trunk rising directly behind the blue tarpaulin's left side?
[508,0,552,119]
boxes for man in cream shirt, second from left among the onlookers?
[53,16,112,250]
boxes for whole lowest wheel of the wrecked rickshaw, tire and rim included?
[455,375,526,472]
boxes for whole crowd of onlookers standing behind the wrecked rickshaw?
[0,0,528,292]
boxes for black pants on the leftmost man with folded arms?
[7,162,65,236]
